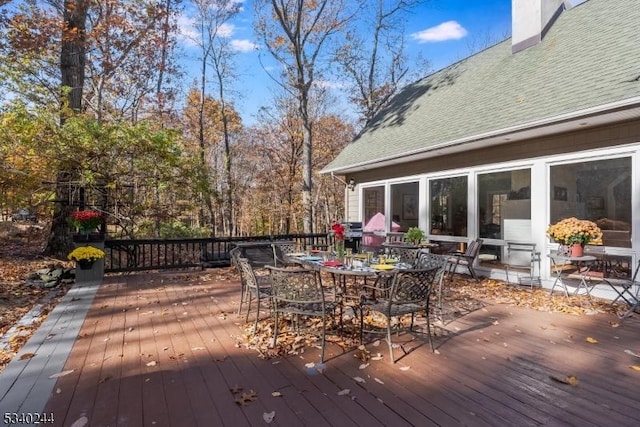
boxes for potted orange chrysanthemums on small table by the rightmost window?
[547,217,602,257]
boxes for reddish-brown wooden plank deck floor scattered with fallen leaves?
[8,270,640,427]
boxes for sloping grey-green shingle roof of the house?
[324,0,640,171]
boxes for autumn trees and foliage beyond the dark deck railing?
[0,0,430,254]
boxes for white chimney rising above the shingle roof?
[511,0,565,53]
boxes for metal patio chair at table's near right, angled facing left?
[360,254,447,364]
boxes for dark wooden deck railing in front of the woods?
[104,233,329,273]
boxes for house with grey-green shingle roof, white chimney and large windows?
[323,0,640,286]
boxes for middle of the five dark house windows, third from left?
[429,176,468,236]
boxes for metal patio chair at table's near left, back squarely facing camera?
[267,266,336,362]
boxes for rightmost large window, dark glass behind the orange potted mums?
[549,157,631,248]
